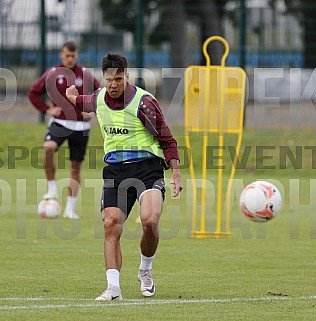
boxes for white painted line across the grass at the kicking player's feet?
[0,295,316,311]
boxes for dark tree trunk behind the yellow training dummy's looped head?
[196,0,224,65]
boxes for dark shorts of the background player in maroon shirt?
[44,122,89,162]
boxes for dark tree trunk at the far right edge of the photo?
[303,0,316,68]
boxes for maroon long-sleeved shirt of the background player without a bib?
[28,64,100,121]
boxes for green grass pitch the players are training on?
[0,124,316,321]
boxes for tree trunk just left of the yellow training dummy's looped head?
[165,0,186,68]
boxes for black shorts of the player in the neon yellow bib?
[101,157,165,216]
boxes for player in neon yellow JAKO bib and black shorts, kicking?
[66,54,182,301]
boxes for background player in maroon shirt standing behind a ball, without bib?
[28,41,100,219]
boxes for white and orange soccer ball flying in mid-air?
[240,181,282,223]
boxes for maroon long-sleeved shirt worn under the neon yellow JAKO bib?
[76,84,180,163]
